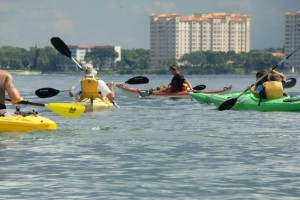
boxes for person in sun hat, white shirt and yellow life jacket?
[69,64,115,100]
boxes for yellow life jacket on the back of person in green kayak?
[263,81,283,99]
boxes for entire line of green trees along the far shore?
[0,46,283,74]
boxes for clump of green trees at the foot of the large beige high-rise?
[178,49,282,73]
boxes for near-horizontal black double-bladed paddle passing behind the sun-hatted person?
[35,76,149,98]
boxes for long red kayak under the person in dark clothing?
[116,84,232,99]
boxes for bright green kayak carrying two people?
[189,91,300,112]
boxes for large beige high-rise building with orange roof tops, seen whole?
[150,13,250,67]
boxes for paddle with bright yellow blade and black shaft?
[6,99,85,118]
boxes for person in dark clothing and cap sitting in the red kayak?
[168,64,193,92]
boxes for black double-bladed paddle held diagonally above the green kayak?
[219,49,298,111]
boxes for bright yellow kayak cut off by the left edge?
[0,110,56,132]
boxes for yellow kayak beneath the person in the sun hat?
[74,97,113,111]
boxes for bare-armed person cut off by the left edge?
[0,70,23,109]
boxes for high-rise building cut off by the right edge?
[284,11,300,71]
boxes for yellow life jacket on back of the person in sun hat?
[80,78,99,98]
